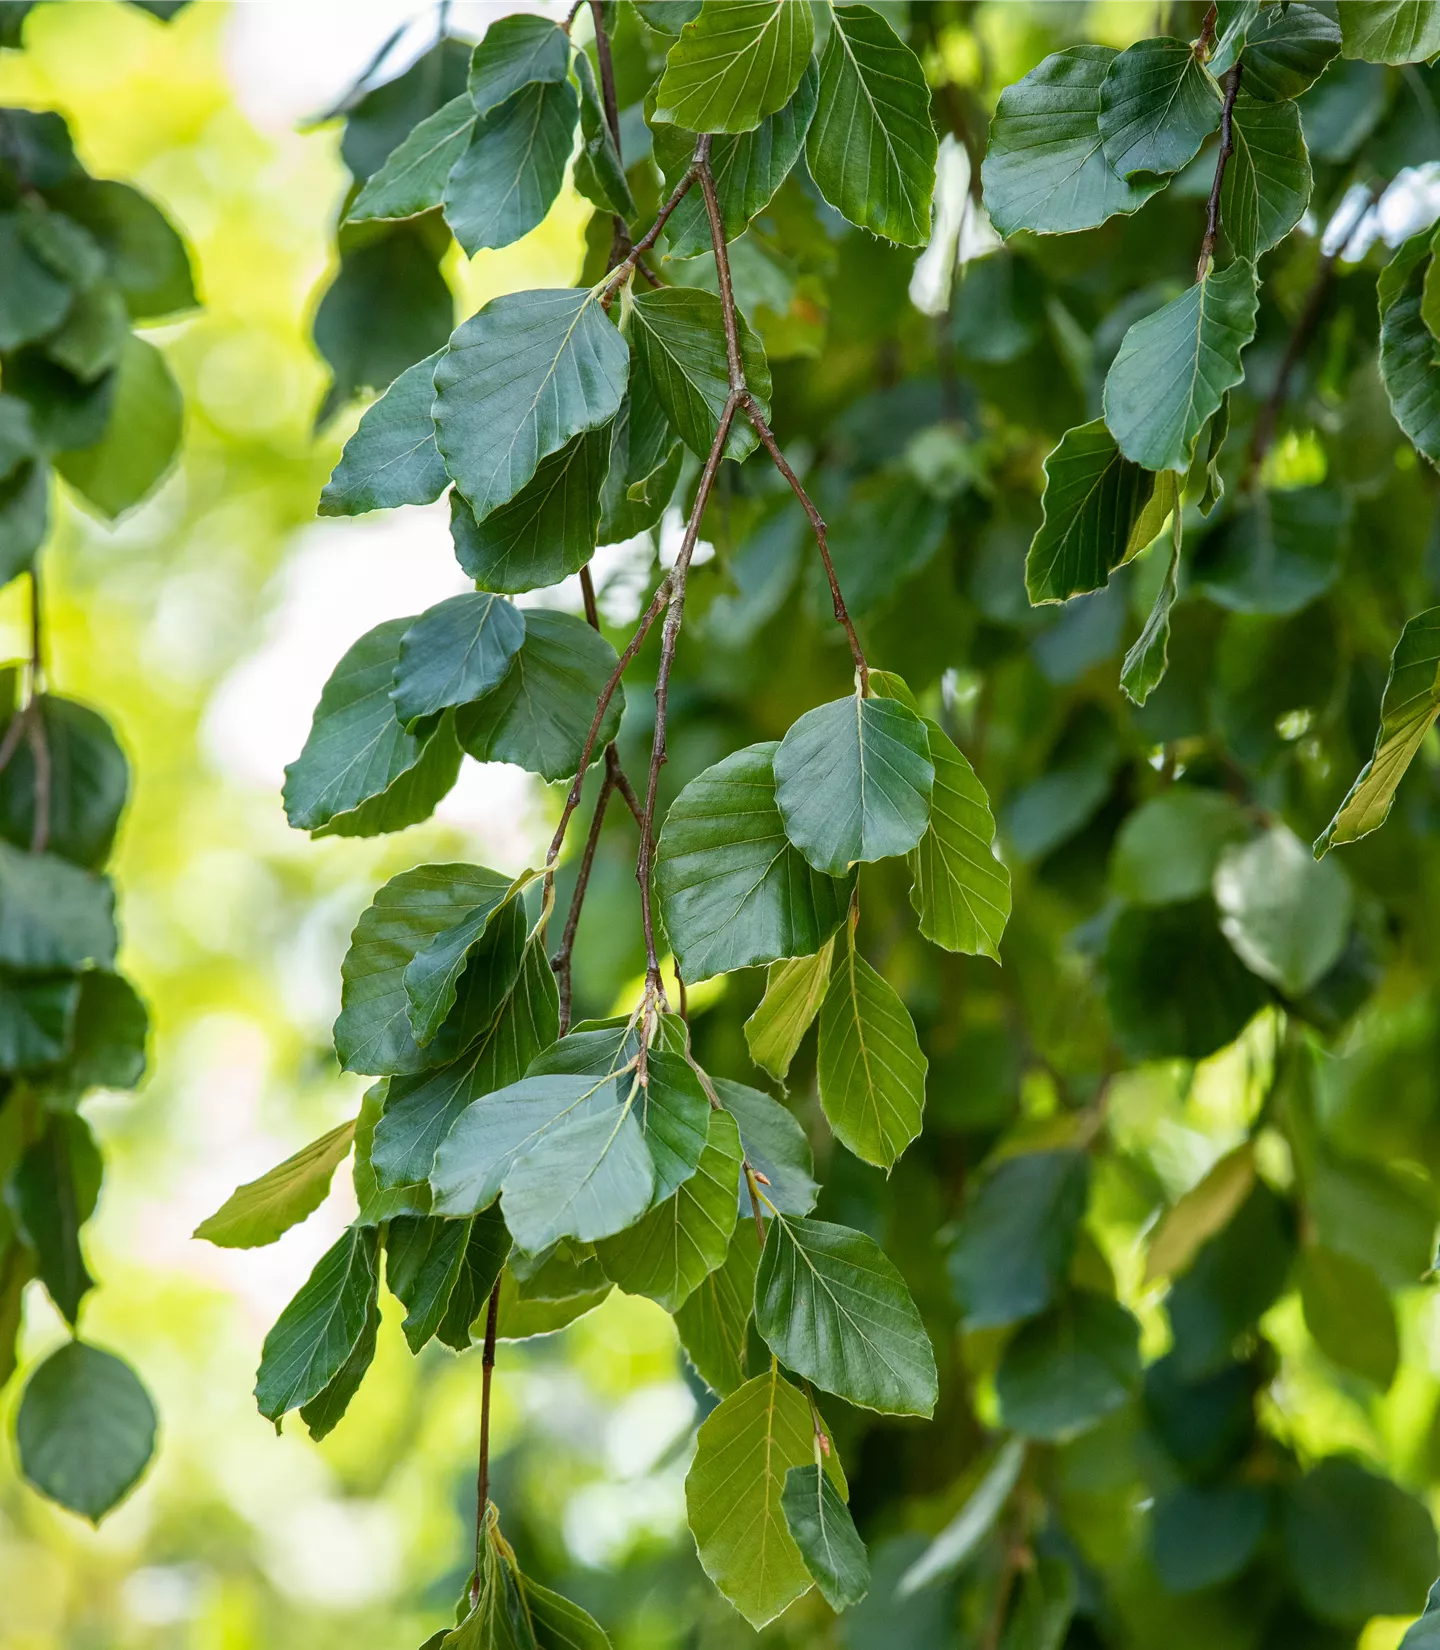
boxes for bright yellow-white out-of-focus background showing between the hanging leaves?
[0,0,1440,1650]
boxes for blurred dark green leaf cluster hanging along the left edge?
[0,3,195,1521]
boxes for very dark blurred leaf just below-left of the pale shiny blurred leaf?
[1105,899,1267,1061]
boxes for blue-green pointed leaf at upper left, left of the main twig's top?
[445,81,579,257]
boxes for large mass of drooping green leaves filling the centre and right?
[201,0,1440,1647]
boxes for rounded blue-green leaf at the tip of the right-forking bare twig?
[774,695,935,876]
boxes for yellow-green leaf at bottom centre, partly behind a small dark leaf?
[685,1365,841,1629]
